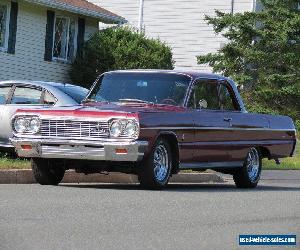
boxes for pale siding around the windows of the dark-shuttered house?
[0,1,98,82]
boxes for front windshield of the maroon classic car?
[87,72,191,105]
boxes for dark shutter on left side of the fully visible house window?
[44,10,55,61]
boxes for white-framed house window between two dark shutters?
[53,16,76,61]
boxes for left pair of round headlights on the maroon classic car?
[13,116,41,134]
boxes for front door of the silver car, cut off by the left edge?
[0,84,12,147]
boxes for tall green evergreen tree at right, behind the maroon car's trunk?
[198,0,300,128]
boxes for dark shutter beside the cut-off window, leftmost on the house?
[7,2,18,54]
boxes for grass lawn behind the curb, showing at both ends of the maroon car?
[0,142,300,170]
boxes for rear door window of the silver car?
[11,87,42,105]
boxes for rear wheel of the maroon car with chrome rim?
[233,148,262,188]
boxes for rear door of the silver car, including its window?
[0,85,44,145]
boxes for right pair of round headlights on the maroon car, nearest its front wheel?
[109,119,139,139]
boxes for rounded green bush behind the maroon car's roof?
[70,27,174,86]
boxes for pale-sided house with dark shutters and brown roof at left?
[0,0,125,82]
